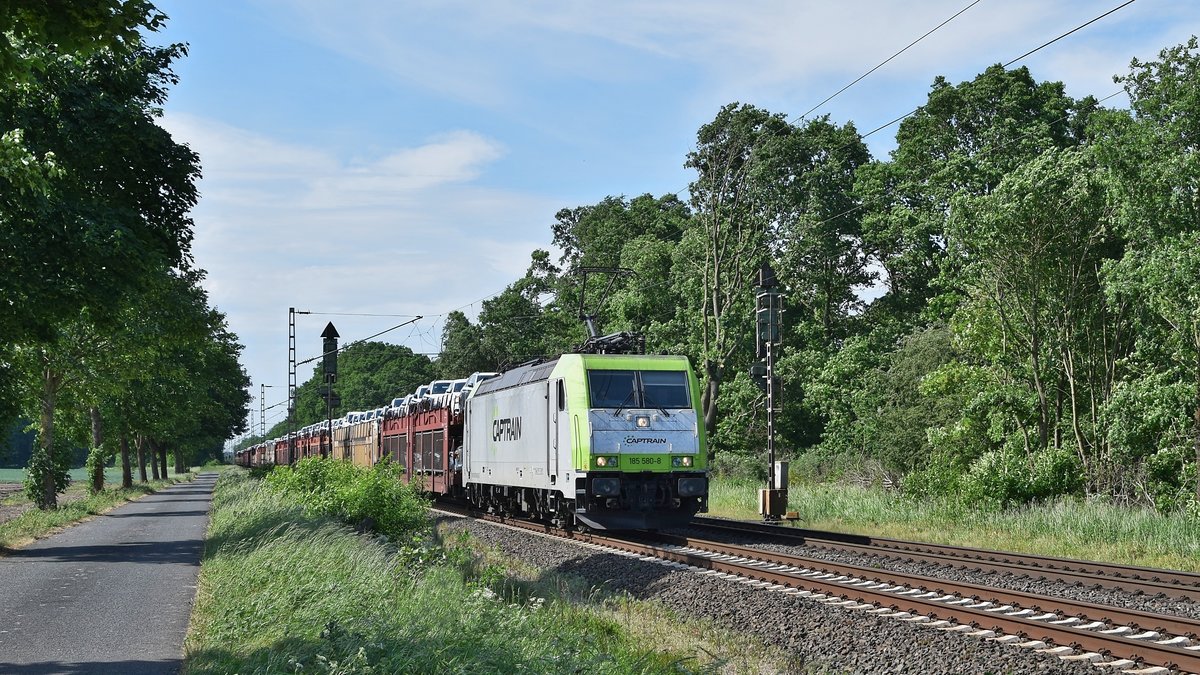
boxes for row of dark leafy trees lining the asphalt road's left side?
[0,0,250,508]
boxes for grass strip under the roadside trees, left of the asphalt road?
[0,473,196,555]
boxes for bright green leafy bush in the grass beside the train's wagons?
[264,458,428,539]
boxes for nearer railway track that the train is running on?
[439,507,1200,675]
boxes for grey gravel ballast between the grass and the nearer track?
[444,518,1102,675]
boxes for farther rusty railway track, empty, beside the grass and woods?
[692,518,1200,602]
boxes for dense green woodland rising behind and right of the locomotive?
[437,38,1200,509]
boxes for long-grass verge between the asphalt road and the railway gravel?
[184,472,729,675]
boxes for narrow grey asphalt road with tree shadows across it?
[0,473,216,675]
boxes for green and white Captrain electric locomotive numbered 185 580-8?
[462,353,708,530]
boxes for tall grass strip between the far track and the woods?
[709,478,1200,572]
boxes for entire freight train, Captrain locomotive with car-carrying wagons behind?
[236,334,708,530]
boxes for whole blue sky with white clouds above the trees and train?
[152,0,1200,432]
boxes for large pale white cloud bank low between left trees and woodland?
[163,115,557,391]
